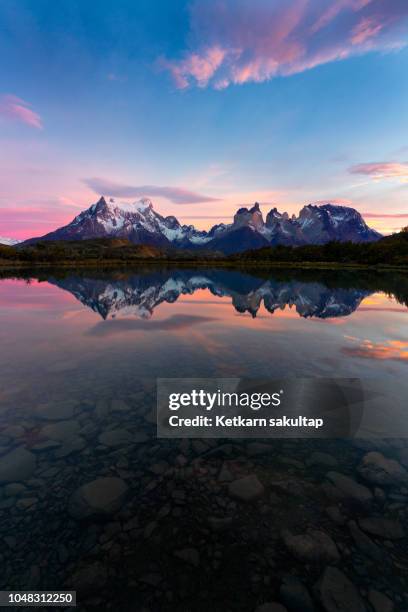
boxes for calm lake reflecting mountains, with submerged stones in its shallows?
[0,266,408,612]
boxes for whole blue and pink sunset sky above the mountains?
[0,0,408,239]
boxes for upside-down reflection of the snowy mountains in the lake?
[48,270,371,319]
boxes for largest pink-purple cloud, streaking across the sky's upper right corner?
[159,0,408,89]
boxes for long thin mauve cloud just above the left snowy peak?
[83,177,219,204]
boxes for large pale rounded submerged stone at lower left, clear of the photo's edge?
[68,478,128,519]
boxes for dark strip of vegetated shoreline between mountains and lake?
[0,227,408,268]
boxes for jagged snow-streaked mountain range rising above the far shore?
[23,197,382,254]
